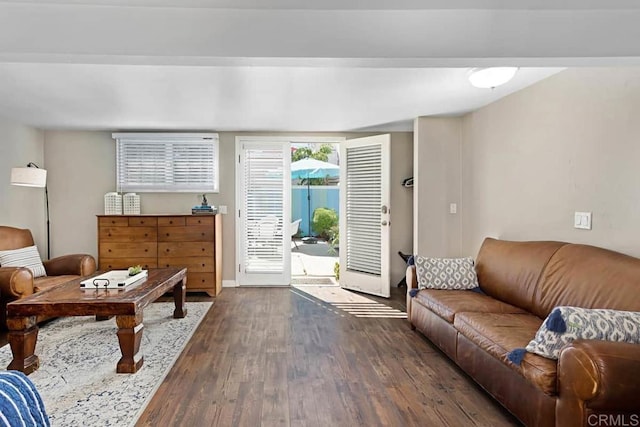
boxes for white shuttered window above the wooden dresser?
[113,133,219,193]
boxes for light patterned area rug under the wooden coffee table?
[0,302,213,427]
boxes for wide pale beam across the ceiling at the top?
[0,0,640,67]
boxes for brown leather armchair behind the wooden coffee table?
[0,226,96,329]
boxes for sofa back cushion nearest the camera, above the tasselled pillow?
[531,244,640,318]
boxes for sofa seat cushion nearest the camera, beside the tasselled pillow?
[454,312,557,395]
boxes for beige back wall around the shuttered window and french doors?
[45,131,412,284]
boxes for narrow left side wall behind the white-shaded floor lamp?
[0,118,47,258]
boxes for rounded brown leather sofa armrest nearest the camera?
[556,340,640,426]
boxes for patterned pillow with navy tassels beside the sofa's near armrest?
[526,307,640,359]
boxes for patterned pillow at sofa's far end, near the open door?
[415,256,478,289]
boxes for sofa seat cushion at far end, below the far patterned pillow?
[414,289,524,324]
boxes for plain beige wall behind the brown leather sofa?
[462,68,640,256]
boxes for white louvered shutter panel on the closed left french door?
[243,146,288,274]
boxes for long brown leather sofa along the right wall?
[407,238,640,427]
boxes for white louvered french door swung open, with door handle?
[340,134,391,297]
